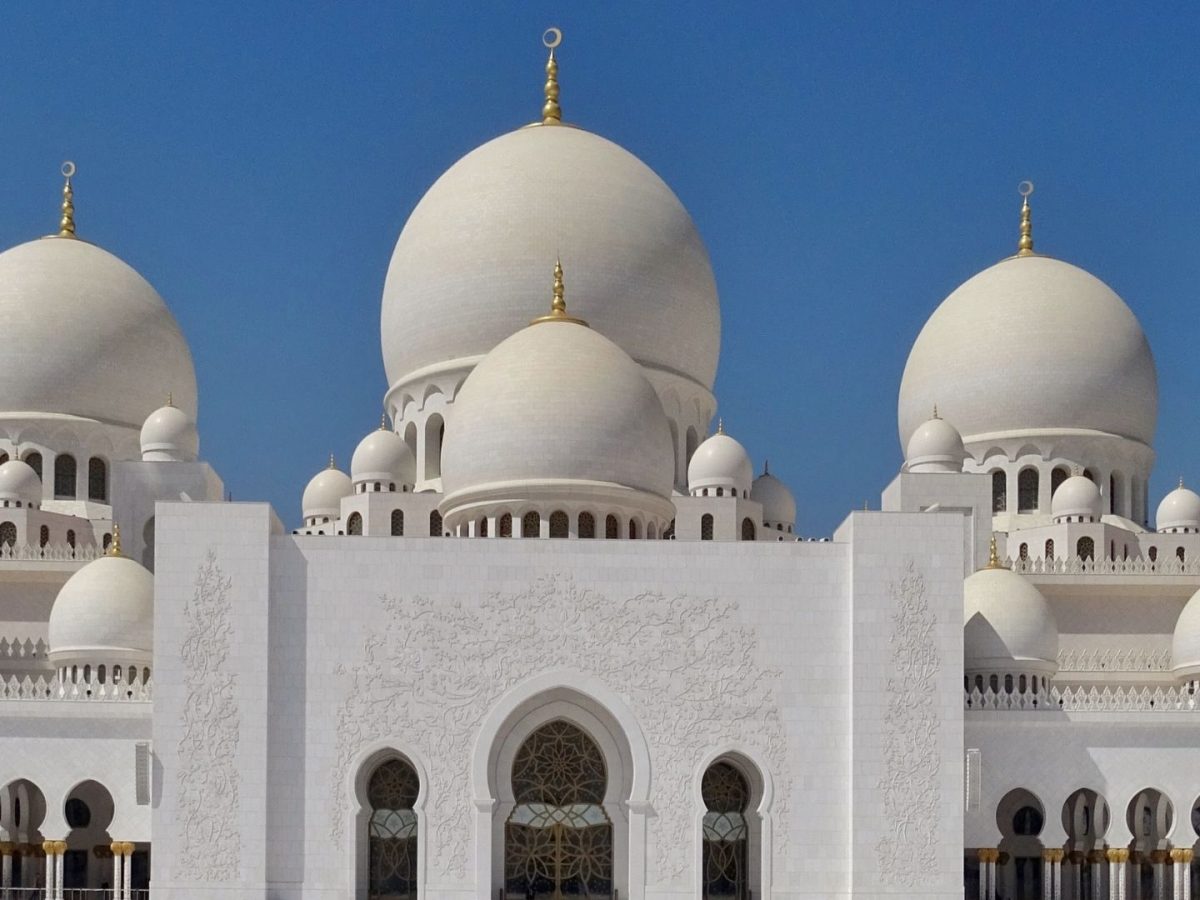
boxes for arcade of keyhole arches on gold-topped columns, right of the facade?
[965,787,1200,900]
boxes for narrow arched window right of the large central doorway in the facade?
[700,762,750,900]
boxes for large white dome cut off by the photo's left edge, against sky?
[0,238,196,428]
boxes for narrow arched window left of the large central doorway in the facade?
[367,760,421,900]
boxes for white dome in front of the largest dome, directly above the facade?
[442,309,674,526]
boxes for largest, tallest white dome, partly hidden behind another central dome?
[380,125,721,389]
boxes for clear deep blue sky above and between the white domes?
[0,0,1200,535]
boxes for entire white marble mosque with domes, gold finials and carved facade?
[0,30,1200,900]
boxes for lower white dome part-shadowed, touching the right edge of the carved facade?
[962,566,1058,674]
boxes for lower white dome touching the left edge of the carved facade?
[48,556,154,667]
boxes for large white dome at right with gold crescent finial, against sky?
[899,256,1158,446]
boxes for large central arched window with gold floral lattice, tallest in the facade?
[502,720,613,900]
